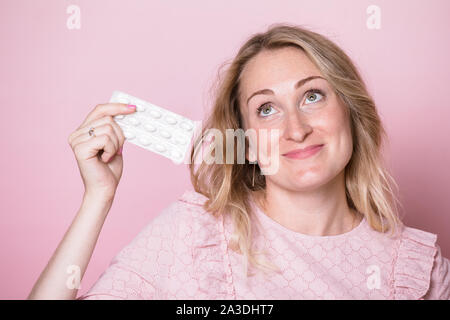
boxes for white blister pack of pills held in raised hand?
[110,91,199,164]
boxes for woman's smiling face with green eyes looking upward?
[240,48,353,191]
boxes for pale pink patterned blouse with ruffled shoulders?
[77,190,450,300]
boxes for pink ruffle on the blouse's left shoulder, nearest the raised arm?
[181,191,236,300]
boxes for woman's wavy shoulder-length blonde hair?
[189,23,403,276]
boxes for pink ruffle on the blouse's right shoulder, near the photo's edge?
[393,227,437,300]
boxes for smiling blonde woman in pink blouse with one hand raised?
[29,24,450,299]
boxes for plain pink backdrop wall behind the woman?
[0,0,450,299]
